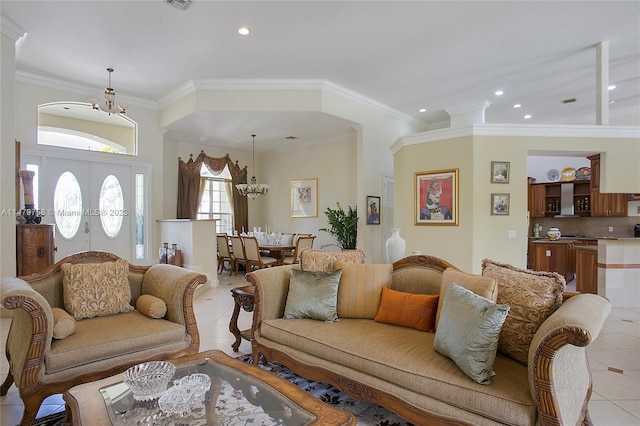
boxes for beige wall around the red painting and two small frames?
[394,125,640,273]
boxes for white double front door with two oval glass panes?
[25,157,144,261]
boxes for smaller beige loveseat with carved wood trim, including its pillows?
[0,251,206,425]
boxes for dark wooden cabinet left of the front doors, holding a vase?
[16,224,55,276]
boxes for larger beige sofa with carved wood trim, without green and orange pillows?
[247,255,610,425]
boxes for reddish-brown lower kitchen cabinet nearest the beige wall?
[531,240,576,281]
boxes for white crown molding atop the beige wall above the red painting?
[390,123,640,154]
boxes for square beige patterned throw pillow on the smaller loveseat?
[61,259,134,320]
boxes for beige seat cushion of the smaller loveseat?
[45,310,189,374]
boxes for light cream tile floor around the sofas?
[0,272,640,426]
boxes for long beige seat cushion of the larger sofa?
[256,318,537,425]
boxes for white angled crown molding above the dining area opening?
[158,78,427,128]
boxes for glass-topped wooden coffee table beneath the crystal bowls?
[64,351,356,426]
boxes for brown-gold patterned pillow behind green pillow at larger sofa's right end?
[482,259,566,365]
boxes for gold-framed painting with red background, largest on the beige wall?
[414,169,458,225]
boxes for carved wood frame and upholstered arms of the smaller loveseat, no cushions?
[0,251,207,426]
